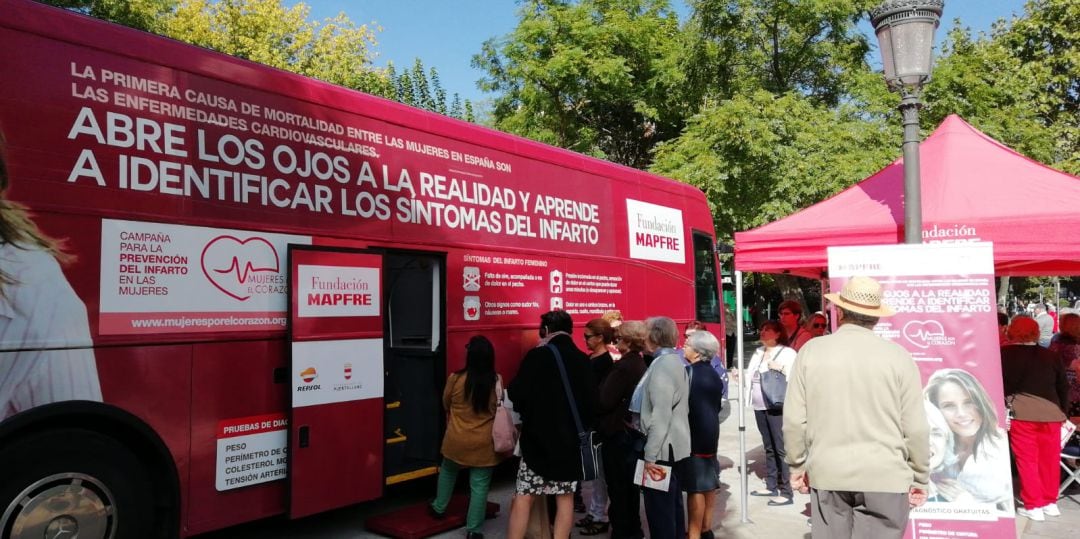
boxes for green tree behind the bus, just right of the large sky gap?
[473,0,692,167]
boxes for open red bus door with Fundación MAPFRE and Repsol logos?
[288,245,383,518]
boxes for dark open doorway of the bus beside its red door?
[382,251,446,485]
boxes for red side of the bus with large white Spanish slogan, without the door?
[0,0,721,535]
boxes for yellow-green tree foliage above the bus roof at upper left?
[39,0,475,121]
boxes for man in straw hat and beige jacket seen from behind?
[784,277,930,539]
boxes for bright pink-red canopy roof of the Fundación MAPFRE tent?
[735,114,1080,279]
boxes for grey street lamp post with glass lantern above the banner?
[870,0,945,243]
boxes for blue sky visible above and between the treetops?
[288,0,1024,102]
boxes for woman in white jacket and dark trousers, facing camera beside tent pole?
[745,320,795,506]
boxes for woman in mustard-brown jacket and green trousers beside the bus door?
[430,335,501,539]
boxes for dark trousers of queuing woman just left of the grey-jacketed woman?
[600,431,645,539]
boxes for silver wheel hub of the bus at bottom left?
[0,473,117,539]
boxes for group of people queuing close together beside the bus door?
[429,310,727,539]
